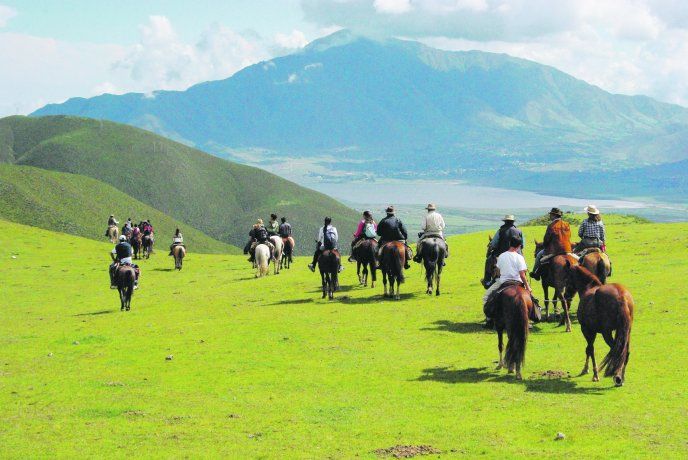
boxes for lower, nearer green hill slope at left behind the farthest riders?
[0,164,240,254]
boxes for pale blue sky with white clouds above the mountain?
[0,0,688,116]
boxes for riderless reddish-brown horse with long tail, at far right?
[569,265,634,387]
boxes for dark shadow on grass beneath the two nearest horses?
[416,367,608,395]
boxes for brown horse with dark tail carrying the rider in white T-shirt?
[493,284,540,380]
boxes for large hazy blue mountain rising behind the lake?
[34,31,688,200]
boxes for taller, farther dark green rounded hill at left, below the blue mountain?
[0,116,357,246]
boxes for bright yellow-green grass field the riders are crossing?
[0,218,688,458]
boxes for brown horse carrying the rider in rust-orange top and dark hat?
[535,241,578,332]
